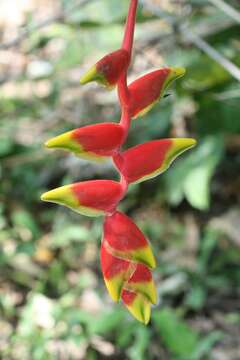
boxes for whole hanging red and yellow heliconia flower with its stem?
[41,0,195,324]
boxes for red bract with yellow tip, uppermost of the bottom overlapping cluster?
[103,211,156,268]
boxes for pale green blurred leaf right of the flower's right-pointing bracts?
[164,136,223,210]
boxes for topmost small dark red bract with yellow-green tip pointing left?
[80,49,130,89]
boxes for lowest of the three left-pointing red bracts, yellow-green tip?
[41,180,123,216]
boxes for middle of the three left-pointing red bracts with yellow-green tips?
[45,123,124,161]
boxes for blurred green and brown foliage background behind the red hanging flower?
[0,0,240,360]
